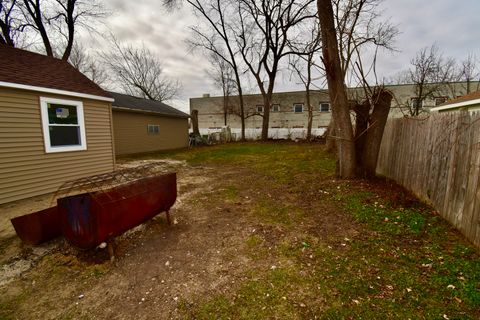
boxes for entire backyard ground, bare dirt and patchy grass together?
[0,143,480,319]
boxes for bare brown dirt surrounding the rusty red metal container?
[0,156,350,319]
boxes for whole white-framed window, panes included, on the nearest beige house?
[40,97,87,153]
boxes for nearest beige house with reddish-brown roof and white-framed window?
[0,45,115,203]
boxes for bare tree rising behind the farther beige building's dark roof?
[101,39,180,101]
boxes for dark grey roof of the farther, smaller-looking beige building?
[109,92,190,118]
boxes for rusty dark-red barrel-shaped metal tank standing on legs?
[57,173,177,249]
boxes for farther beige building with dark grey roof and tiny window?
[110,92,190,155]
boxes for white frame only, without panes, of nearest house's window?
[40,97,87,153]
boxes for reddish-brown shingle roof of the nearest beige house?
[0,45,111,98]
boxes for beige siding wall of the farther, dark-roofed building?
[112,110,188,155]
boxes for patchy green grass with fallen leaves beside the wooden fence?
[170,144,480,319]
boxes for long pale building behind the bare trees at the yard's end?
[190,82,478,138]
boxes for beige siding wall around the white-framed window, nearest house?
[0,88,115,203]
